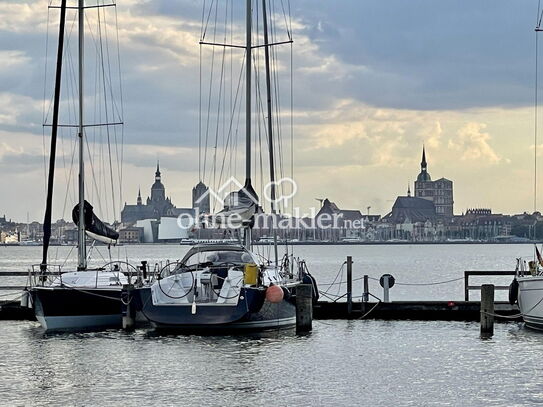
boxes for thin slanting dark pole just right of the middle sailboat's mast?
[262,0,279,265]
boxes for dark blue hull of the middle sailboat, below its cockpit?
[133,287,296,332]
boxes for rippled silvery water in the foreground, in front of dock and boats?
[0,320,543,406]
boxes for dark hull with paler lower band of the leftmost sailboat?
[30,287,122,331]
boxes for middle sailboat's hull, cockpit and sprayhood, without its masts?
[133,244,300,331]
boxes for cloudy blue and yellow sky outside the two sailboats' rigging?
[0,0,543,221]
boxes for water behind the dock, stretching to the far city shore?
[0,244,534,300]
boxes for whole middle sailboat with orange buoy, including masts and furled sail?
[133,0,311,333]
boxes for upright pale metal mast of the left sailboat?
[77,0,87,270]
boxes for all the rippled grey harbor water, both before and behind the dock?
[0,245,543,406]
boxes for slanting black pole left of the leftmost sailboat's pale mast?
[40,0,66,271]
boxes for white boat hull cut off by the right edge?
[517,276,543,330]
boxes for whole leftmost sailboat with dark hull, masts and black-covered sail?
[28,0,129,331]
